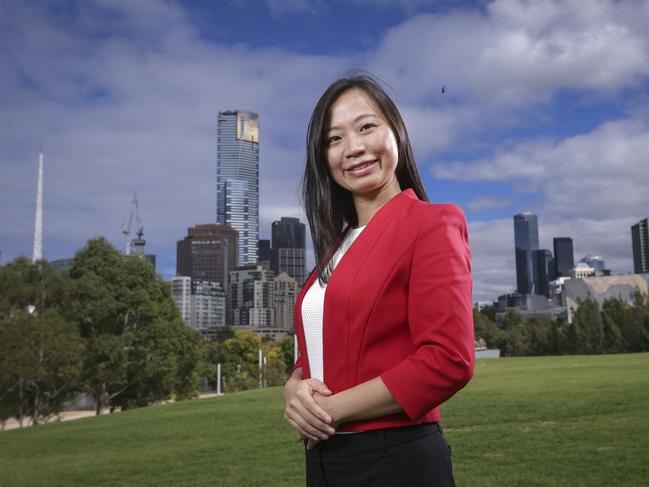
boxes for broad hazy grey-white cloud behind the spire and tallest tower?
[0,1,351,266]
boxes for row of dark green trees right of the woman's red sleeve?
[473,290,649,356]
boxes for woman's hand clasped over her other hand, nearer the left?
[284,368,336,440]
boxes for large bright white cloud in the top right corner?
[370,0,649,105]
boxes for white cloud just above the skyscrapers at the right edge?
[434,118,649,219]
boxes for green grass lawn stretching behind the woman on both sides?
[0,353,649,487]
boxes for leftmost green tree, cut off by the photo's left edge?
[0,257,81,425]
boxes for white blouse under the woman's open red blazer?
[302,225,365,382]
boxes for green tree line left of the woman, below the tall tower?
[0,238,292,425]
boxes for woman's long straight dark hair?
[302,73,428,283]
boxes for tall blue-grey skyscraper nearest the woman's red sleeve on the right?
[514,213,539,294]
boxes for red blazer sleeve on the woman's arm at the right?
[381,205,475,421]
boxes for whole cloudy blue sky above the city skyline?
[0,0,649,300]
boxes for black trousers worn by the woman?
[305,423,455,487]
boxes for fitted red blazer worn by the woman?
[295,189,474,431]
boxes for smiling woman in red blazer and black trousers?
[284,75,474,486]
